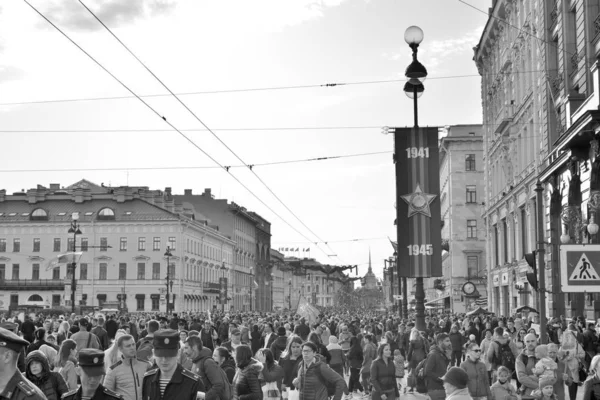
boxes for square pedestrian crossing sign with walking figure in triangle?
[560,244,600,293]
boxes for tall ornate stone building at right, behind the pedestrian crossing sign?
[474,0,600,317]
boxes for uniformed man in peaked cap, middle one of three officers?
[62,349,123,400]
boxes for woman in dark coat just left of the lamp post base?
[371,343,400,400]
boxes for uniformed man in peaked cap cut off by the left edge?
[0,328,46,400]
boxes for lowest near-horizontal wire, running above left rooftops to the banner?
[0,151,393,173]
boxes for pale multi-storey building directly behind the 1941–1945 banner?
[434,125,487,313]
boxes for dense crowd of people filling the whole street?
[0,308,600,400]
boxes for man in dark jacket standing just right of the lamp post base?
[423,333,452,400]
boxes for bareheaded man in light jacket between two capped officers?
[104,335,150,400]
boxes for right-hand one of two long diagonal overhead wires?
[78,0,343,263]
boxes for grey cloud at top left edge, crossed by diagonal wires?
[40,0,176,31]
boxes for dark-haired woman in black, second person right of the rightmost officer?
[233,344,263,400]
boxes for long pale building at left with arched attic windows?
[0,180,235,312]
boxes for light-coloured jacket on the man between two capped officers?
[104,358,151,400]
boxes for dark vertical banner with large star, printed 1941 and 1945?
[394,127,442,278]
